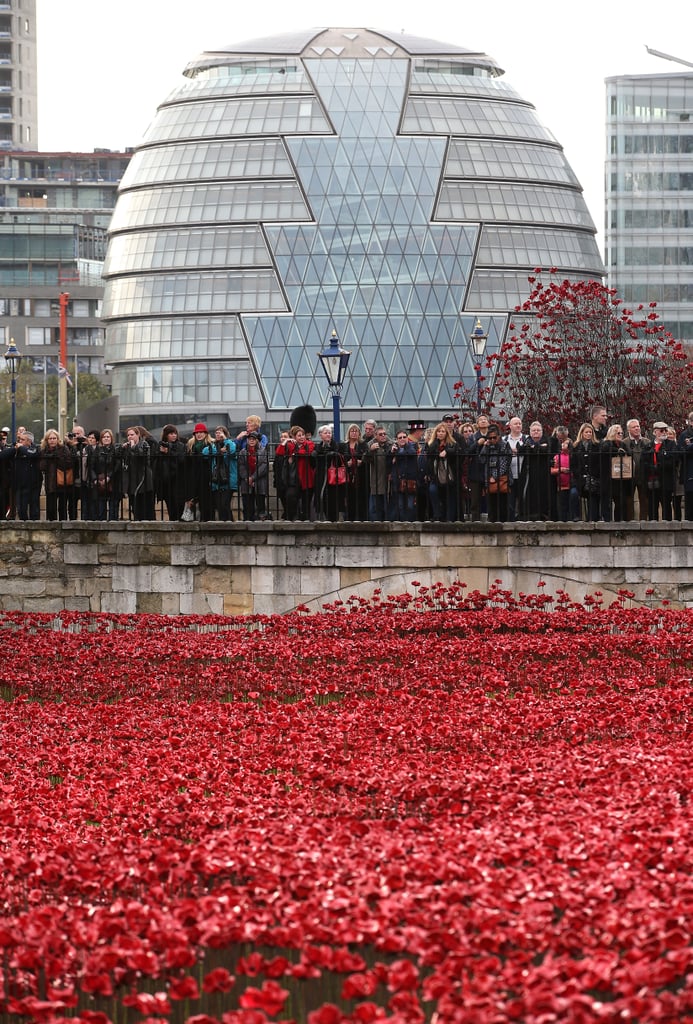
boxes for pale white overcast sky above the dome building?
[37,0,693,253]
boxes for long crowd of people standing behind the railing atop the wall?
[0,406,693,522]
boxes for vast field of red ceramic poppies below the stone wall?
[0,584,693,1024]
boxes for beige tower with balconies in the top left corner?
[0,0,39,150]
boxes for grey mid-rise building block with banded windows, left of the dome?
[0,151,130,374]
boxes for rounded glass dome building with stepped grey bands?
[103,29,604,432]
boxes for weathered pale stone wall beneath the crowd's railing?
[0,522,693,614]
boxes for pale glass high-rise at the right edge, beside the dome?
[605,68,693,346]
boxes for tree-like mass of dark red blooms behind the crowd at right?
[456,270,693,436]
